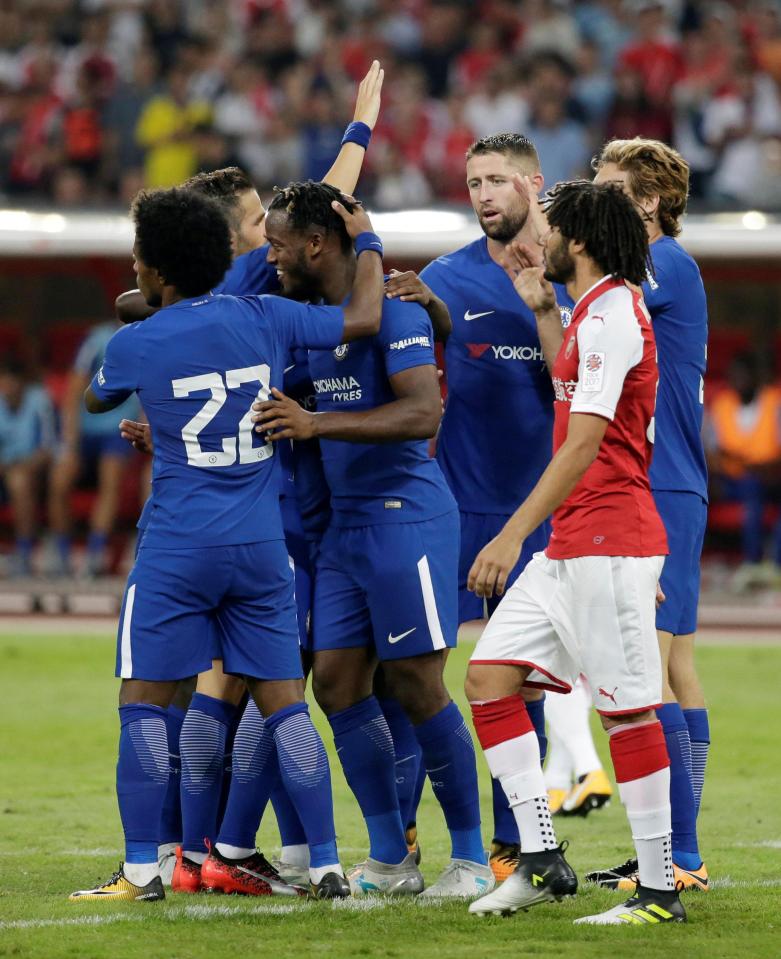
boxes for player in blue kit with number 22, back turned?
[71,189,382,902]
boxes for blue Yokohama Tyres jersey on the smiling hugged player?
[309,300,456,526]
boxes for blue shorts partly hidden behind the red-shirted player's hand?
[458,513,550,624]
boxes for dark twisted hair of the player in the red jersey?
[545,180,652,286]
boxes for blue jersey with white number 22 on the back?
[92,294,344,548]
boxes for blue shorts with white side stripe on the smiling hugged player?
[313,510,458,660]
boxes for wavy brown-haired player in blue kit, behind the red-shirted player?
[586,137,710,892]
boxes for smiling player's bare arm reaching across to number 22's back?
[253,366,442,443]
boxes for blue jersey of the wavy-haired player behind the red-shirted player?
[643,236,708,500]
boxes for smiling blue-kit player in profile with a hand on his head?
[256,182,494,897]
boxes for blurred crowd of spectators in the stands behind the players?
[0,0,781,209]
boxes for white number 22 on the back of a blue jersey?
[171,363,274,469]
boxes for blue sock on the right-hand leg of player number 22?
[266,703,341,869]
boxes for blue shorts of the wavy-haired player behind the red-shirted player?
[653,490,708,636]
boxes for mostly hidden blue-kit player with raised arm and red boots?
[117,60,384,894]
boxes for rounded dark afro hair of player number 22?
[130,187,232,297]
